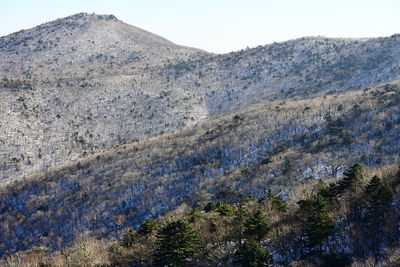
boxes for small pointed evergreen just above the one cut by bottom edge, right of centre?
[244,210,271,241]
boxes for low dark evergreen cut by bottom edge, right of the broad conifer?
[235,242,272,267]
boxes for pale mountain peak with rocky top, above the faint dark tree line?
[0,13,202,80]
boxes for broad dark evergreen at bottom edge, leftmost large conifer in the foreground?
[154,220,200,266]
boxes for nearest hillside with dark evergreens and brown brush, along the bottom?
[1,164,400,267]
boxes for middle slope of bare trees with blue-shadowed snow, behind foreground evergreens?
[0,84,400,260]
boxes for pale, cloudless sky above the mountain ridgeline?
[0,0,400,53]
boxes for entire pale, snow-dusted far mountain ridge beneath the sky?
[0,14,400,182]
